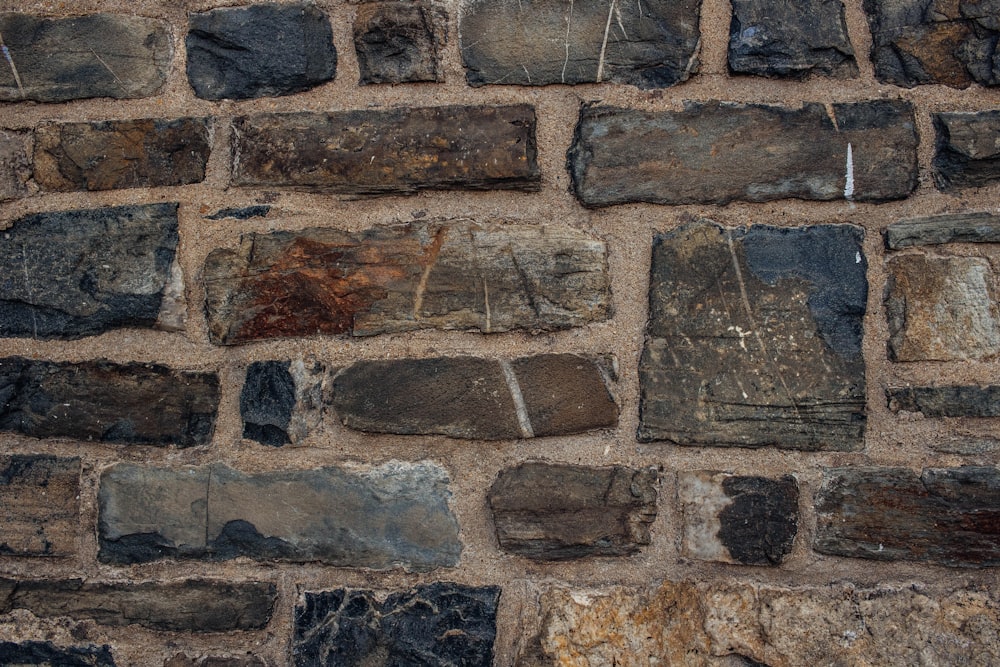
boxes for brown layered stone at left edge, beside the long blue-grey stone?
[0,454,80,556]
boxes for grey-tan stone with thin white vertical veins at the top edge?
[459,0,701,88]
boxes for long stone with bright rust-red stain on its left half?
[202,220,610,345]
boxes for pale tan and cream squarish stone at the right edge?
[885,254,1000,361]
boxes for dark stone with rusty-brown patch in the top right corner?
[864,0,1000,88]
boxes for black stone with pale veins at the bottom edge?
[292,582,500,667]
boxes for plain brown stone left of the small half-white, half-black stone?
[487,462,657,560]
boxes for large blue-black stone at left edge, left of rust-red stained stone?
[0,204,178,338]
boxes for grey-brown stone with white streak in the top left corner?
[0,14,173,102]
